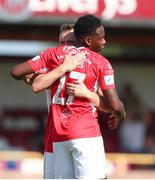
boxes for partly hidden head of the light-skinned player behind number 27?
[59,24,75,45]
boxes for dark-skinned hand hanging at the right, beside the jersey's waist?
[108,113,120,129]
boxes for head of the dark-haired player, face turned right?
[74,14,106,52]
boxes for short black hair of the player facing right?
[74,14,102,40]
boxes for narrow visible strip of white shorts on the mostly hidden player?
[44,152,54,179]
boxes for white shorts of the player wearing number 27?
[53,136,106,179]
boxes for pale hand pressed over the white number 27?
[66,81,89,97]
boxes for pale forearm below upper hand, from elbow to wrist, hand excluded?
[32,64,67,93]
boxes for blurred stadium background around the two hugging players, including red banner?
[0,0,155,179]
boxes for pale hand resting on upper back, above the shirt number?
[63,52,86,72]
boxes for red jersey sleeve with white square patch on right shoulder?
[98,59,115,90]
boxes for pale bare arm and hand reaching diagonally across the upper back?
[32,52,85,93]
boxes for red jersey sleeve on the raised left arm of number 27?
[28,49,52,73]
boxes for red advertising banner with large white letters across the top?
[0,0,155,24]
